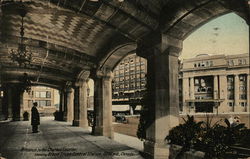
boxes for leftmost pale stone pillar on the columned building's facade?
[182,77,190,114]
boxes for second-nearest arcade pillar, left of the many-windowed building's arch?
[92,68,114,139]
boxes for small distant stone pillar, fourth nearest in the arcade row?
[66,88,74,122]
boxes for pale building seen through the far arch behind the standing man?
[23,86,59,116]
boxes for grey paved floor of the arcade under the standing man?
[0,118,142,159]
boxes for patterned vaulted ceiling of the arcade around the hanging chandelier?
[0,0,249,87]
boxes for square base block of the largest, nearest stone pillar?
[143,141,170,159]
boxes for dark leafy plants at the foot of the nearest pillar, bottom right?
[166,116,250,159]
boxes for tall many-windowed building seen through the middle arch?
[112,54,147,114]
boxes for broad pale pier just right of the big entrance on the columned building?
[218,75,230,113]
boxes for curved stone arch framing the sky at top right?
[161,0,249,40]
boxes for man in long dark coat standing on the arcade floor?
[31,102,40,133]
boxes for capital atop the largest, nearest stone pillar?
[136,31,183,58]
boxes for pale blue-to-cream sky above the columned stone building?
[180,13,249,59]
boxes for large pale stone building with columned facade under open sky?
[180,53,250,114]
